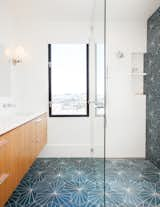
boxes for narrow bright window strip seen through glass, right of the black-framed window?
[96,43,104,116]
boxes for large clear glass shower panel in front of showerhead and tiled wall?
[105,0,160,207]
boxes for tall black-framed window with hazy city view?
[48,44,89,117]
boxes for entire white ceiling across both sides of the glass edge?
[6,0,160,22]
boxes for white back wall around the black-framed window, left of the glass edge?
[12,21,103,157]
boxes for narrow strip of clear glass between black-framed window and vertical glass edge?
[89,0,105,207]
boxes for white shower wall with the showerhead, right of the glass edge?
[106,20,147,158]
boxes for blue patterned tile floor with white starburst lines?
[5,158,160,207]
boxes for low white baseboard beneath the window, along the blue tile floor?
[39,144,104,158]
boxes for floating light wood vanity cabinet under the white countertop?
[0,114,47,207]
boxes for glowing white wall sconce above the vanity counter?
[5,46,26,65]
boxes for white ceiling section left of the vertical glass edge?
[8,0,104,22]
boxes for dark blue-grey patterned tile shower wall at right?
[144,8,160,167]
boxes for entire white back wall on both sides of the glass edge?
[9,17,146,157]
